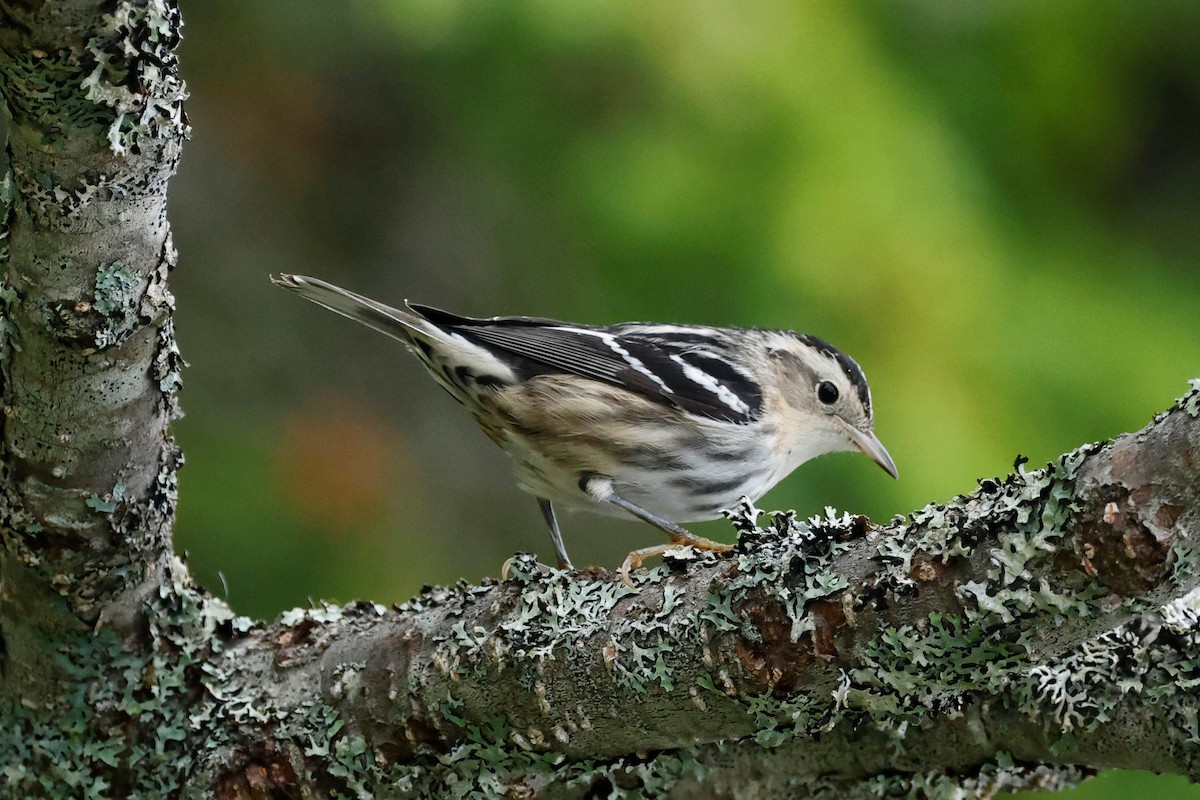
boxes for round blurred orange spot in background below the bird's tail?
[275,395,409,534]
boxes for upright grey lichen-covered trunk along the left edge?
[0,2,187,719]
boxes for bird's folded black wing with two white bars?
[409,303,762,423]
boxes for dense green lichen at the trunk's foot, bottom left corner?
[0,568,274,800]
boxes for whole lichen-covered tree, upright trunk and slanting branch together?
[0,0,1200,798]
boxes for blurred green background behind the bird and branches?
[170,0,1200,798]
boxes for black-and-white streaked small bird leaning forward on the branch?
[271,273,898,588]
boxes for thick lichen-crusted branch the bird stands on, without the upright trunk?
[218,389,1200,796]
